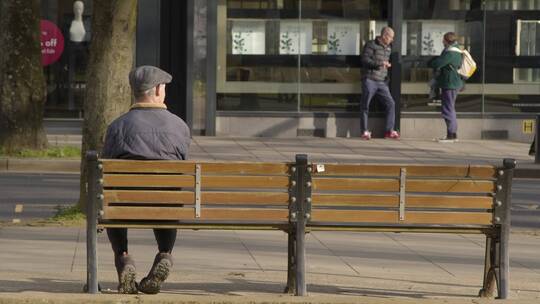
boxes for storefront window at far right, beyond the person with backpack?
[483,0,540,113]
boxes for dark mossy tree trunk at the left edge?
[0,0,47,153]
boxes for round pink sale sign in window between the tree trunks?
[41,20,64,66]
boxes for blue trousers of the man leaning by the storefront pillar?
[360,78,396,132]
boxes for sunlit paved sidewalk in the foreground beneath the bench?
[0,227,540,303]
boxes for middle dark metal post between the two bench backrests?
[296,154,307,296]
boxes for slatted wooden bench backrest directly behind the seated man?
[94,159,296,226]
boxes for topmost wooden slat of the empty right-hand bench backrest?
[313,164,496,179]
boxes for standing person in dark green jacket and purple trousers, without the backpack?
[428,32,463,142]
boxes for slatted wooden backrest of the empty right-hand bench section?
[307,164,510,229]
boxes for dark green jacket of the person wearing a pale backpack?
[428,43,463,90]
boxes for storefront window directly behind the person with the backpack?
[401,0,483,112]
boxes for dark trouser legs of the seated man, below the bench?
[107,228,176,256]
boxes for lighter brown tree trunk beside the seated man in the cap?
[79,0,137,211]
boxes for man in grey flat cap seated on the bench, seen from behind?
[103,66,191,294]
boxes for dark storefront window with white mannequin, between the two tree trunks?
[41,0,93,118]
